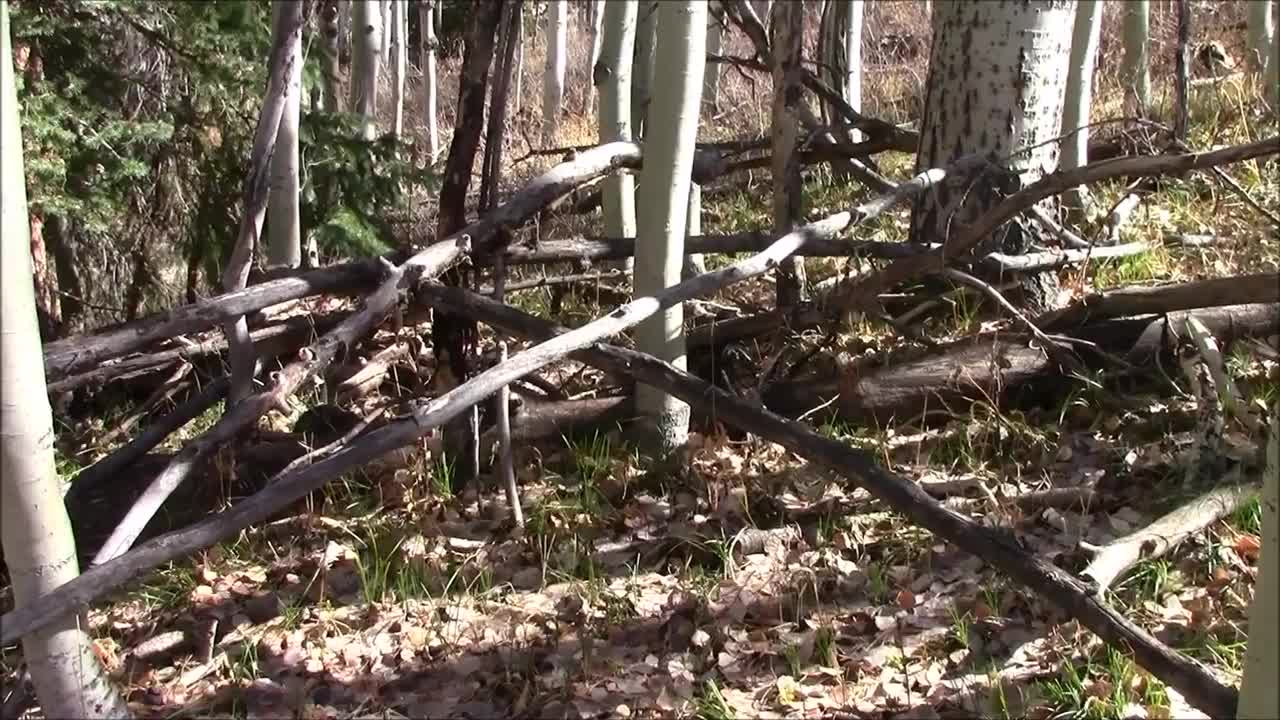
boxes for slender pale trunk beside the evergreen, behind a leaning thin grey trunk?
[266,0,302,268]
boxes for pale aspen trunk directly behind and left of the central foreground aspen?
[591,0,640,263]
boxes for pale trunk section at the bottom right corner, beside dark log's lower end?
[1235,402,1280,720]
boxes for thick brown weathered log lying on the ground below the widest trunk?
[763,304,1280,423]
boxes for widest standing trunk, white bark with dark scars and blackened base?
[911,0,1075,309]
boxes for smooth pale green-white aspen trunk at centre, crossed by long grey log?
[635,0,707,456]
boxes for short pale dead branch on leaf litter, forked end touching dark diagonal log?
[1080,484,1258,601]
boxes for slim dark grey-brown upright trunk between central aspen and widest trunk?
[769,3,805,307]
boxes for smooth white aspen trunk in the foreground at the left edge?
[0,3,132,717]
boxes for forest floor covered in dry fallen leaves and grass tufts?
[0,2,1280,720]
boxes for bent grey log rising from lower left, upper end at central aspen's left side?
[93,142,650,565]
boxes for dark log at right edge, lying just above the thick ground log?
[1034,273,1280,332]
